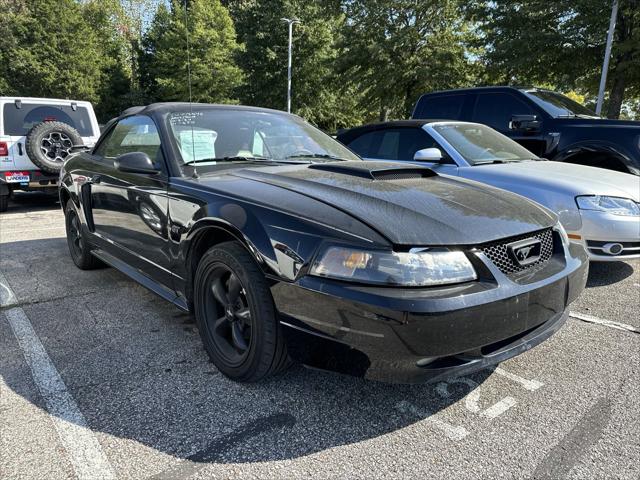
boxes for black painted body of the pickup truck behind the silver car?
[411,87,640,175]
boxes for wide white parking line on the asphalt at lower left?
[0,273,116,480]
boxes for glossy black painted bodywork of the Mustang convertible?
[60,104,587,382]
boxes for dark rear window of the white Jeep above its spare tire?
[2,103,93,137]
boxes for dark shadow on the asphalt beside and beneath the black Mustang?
[0,238,491,472]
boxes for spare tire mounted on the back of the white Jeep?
[25,122,83,173]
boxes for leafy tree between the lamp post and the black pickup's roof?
[342,0,477,120]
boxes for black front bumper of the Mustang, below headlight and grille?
[272,245,588,383]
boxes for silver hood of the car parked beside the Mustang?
[460,161,640,202]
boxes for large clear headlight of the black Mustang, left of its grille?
[311,246,477,287]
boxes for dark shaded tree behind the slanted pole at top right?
[467,0,640,118]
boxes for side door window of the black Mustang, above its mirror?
[94,115,163,165]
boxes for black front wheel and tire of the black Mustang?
[194,242,289,382]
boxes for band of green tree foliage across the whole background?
[0,0,640,122]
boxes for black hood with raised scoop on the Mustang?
[231,162,556,246]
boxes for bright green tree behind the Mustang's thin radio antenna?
[140,0,242,103]
